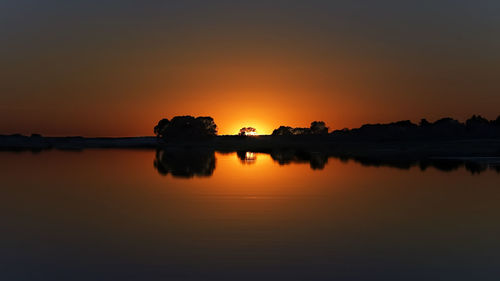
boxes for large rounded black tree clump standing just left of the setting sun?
[154,116,217,140]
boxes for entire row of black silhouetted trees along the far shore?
[154,115,500,141]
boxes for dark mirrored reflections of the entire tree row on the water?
[154,148,500,178]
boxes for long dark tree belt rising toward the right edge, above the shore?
[330,115,500,140]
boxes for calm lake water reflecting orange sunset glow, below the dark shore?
[0,150,500,281]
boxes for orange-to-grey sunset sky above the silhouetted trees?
[0,0,500,136]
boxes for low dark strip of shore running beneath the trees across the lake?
[0,135,500,158]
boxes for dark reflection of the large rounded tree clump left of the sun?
[154,149,215,178]
